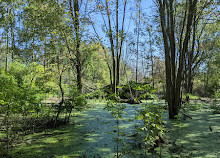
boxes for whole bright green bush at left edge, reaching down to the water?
[0,62,51,154]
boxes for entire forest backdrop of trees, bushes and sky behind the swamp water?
[0,0,220,157]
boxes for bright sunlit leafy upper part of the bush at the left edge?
[0,62,46,115]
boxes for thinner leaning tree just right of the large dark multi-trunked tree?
[184,0,218,101]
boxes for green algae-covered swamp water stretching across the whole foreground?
[10,102,220,158]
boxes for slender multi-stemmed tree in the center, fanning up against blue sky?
[94,0,127,93]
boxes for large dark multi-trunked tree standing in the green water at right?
[157,0,197,119]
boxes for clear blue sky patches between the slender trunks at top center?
[82,0,158,76]
